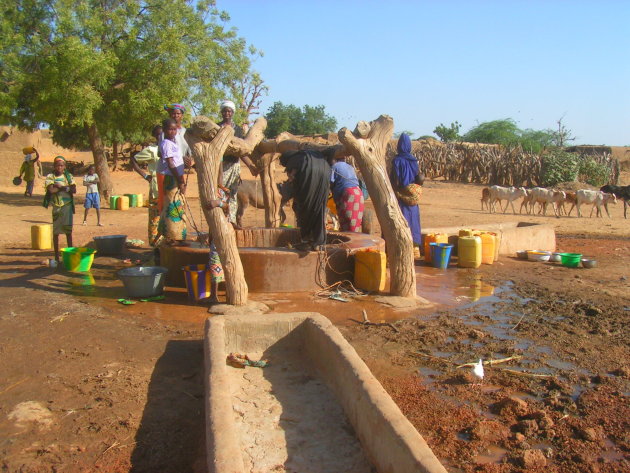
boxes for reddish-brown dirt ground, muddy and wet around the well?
[0,138,630,472]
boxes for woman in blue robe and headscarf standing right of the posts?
[391,133,424,246]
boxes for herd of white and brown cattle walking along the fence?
[481,185,630,218]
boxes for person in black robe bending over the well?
[280,150,331,250]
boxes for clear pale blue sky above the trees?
[222,0,630,146]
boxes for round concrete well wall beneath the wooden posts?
[160,228,385,292]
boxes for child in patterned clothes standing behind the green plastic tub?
[44,156,77,263]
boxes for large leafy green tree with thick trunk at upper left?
[0,0,257,197]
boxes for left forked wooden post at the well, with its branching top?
[186,117,267,305]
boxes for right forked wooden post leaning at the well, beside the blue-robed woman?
[339,115,416,297]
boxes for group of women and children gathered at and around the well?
[20,100,423,300]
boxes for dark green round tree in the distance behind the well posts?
[265,102,337,138]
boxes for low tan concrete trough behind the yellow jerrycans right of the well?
[422,222,556,256]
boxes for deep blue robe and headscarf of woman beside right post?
[392,133,422,245]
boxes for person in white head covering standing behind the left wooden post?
[218,100,258,228]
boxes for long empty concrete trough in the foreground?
[205,313,446,473]
